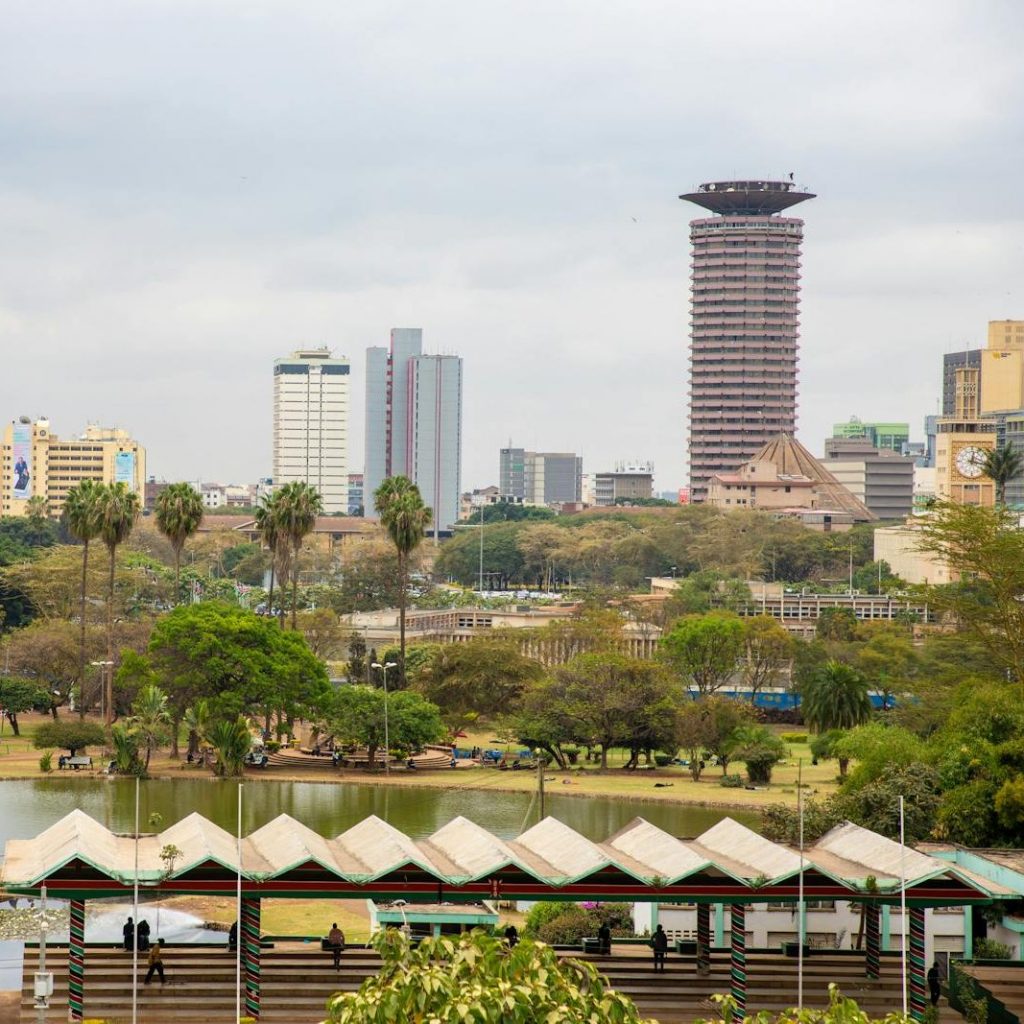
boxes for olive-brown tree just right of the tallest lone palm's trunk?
[413,637,544,727]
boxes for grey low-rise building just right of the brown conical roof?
[821,437,913,519]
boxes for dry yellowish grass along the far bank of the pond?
[0,715,837,808]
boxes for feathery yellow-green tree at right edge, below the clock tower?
[919,502,1024,684]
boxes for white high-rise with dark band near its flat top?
[273,347,349,515]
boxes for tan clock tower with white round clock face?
[935,366,995,507]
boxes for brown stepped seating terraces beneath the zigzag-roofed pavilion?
[22,943,966,1024]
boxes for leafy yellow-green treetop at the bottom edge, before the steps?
[328,929,655,1024]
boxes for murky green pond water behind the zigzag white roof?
[0,778,758,850]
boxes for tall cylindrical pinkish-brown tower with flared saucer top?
[679,181,814,502]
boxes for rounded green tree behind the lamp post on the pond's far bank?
[328,684,444,771]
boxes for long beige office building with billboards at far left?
[0,416,145,516]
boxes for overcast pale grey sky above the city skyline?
[0,0,1024,488]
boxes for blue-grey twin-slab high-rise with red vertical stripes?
[364,328,463,539]
